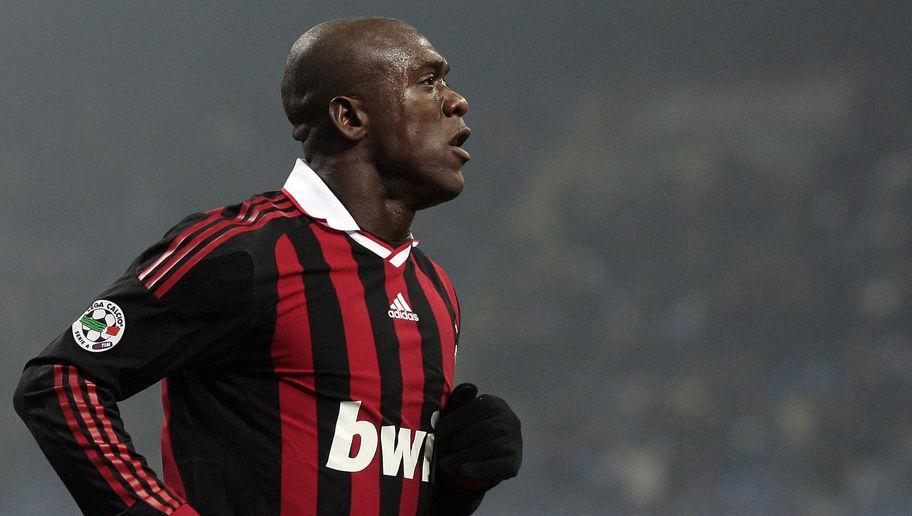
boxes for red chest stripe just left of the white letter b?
[272,235,319,516]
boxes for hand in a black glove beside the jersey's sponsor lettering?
[434,383,522,492]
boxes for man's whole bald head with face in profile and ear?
[282,18,471,216]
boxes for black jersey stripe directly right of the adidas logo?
[405,260,449,514]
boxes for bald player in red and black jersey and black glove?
[15,18,522,515]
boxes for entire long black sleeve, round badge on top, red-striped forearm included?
[14,216,253,515]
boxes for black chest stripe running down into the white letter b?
[288,224,351,514]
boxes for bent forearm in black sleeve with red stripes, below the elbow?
[14,364,195,515]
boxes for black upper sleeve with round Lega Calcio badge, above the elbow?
[26,246,253,400]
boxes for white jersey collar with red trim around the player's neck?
[282,158,418,267]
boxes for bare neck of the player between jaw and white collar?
[308,156,415,242]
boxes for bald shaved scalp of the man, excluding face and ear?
[282,18,424,141]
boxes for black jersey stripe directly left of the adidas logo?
[348,238,402,514]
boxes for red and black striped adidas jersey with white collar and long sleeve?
[16,160,459,515]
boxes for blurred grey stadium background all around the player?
[0,0,912,515]
